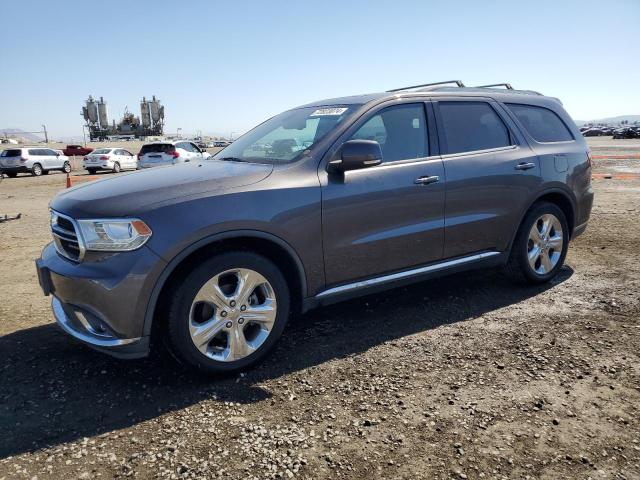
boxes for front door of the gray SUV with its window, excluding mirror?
[318,101,444,285]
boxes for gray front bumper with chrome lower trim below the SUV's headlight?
[36,244,164,358]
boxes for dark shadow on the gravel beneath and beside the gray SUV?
[0,266,573,459]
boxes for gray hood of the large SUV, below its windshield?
[50,160,273,218]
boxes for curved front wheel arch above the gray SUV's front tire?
[143,230,307,336]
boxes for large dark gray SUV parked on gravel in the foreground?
[37,82,593,373]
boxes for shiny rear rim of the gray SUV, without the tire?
[527,213,564,275]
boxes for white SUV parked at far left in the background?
[0,147,71,178]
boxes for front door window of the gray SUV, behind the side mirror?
[350,103,429,162]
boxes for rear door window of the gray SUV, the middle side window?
[438,102,511,154]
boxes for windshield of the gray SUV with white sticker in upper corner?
[213,106,354,163]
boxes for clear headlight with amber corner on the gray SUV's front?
[77,218,151,252]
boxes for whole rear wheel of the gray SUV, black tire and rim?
[505,202,569,285]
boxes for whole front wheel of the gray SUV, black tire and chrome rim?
[165,252,290,374]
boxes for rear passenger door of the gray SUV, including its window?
[434,97,540,258]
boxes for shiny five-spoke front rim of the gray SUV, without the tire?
[189,268,277,362]
